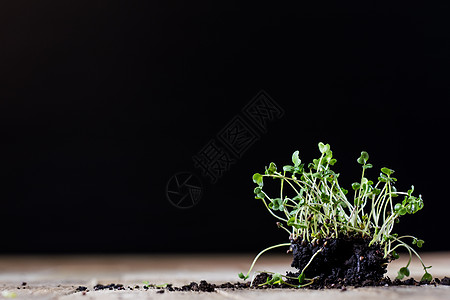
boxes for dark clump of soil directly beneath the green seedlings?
[288,236,391,287]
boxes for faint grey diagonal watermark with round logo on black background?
[166,91,284,209]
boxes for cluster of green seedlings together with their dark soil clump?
[239,143,433,288]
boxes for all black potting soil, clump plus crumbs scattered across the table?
[71,236,450,293]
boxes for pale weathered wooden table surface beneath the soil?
[0,252,450,300]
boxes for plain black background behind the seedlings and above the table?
[0,1,450,253]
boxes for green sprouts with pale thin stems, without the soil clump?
[239,143,432,287]
